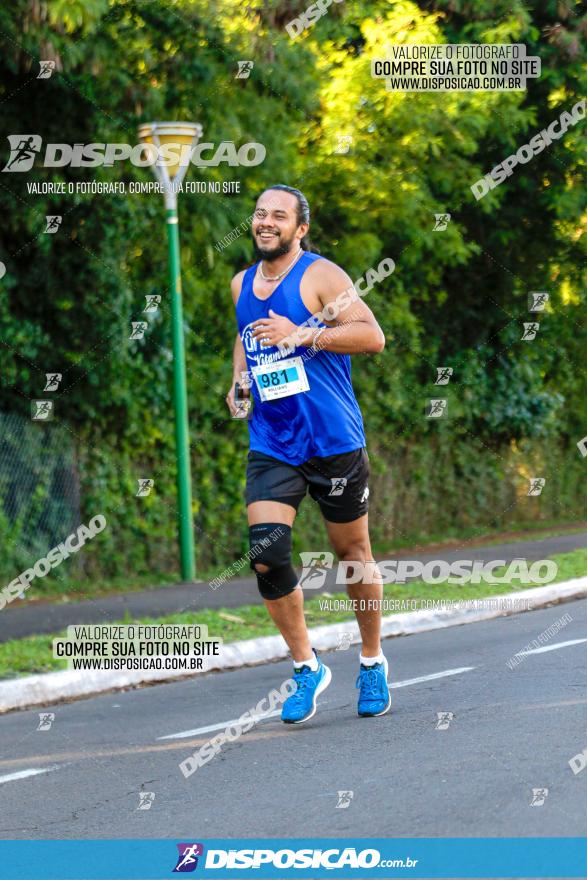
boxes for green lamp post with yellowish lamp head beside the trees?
[138,122,202,581]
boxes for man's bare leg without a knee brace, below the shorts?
[325,513,383,657]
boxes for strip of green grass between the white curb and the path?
[0,549,587,679]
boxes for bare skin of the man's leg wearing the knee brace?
[247,501,312,663]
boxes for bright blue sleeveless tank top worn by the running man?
[236,251,366,465]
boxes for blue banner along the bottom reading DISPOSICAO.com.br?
[0,837,587,880]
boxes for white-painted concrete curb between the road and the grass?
[0,577,587,714]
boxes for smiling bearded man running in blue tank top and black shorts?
[226,184,391,724]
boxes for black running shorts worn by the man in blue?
[246,447,370,523]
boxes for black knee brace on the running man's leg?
[249,523,298,599]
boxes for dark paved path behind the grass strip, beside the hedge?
[0,532,587,642]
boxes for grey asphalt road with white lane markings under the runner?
[0,600,587,840]
